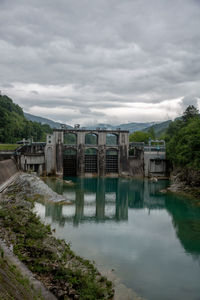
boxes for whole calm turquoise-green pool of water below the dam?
[36,178,200,300]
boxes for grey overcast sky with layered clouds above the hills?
[0,0,200,125]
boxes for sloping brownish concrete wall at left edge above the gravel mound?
[0,159,18,185]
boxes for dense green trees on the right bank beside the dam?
[165,105,200,190]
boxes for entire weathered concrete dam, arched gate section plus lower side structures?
[0,128,167,177]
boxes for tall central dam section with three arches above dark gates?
[45,128,129,177]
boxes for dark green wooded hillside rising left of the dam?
[0,95,52,144]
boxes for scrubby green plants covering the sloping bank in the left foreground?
[0,179,113,300]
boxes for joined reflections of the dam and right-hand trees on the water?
[41,177,200,257]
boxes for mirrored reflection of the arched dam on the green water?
[41,178,167,225]
